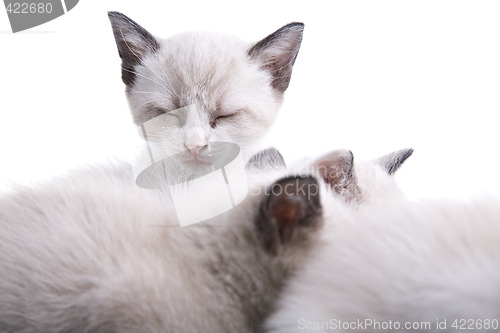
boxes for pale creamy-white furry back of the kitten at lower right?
[266,165,500,332]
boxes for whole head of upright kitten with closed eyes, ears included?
[109,12,303,158]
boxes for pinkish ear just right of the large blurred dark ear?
[313,150,361,200]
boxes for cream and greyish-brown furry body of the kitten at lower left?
[0,165,294,333]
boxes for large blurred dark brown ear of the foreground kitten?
[256,176,322,254]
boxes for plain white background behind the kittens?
[0,0,500,198]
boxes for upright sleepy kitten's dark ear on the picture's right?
[248,22,304,92]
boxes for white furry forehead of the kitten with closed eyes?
[128,32,266,107]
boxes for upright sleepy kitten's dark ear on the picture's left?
[108,12,159,85]
